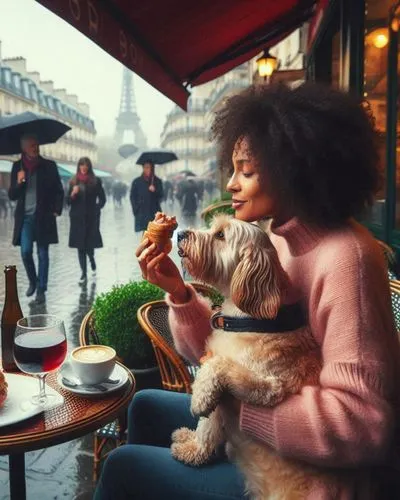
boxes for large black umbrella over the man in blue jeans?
[0,111,71,155]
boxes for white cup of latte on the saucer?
[70,344,116,385]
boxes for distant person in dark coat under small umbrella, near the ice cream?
[130,162,164,232]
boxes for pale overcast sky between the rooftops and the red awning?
[0,0,173,146]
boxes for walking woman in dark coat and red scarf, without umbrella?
[68,156,106,284]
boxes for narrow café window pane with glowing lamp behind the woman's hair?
[364,0,390,225]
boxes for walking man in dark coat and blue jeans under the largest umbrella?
[8,134,64,303]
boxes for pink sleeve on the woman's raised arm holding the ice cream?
[165,284,211,364]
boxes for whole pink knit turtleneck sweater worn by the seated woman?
[167,218,400,500]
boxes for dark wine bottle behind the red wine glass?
[1,266,23,371]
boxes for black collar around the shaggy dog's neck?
[211,302,307,333]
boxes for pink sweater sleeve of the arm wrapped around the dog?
[240,236,400,466]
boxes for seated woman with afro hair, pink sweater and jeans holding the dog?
[95,83,400,500]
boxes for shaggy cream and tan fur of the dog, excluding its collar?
[171,216,336,500]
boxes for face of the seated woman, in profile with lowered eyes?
[226,138,277,222]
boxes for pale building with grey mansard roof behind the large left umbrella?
[0,49,97,165]
